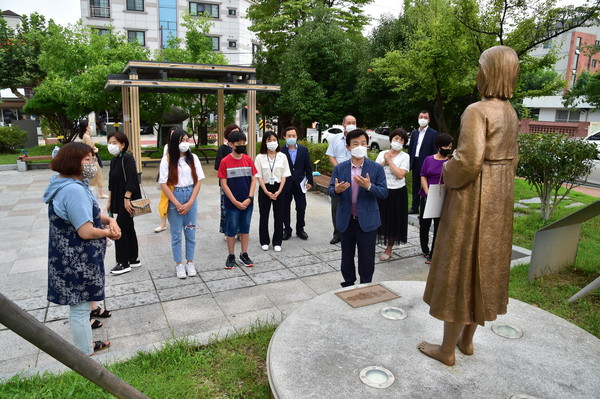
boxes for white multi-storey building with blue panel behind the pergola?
[80,0,258,65]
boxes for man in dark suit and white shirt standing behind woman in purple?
[408,110,438,214]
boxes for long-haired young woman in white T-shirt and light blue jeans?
[158,129,204,278]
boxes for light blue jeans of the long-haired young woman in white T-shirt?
[167,186,198,263]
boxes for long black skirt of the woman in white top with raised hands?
[377,186,408,245]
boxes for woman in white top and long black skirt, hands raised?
[376,129,410,261]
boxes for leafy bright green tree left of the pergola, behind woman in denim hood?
[24,21,148,141]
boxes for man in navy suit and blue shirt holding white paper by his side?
[281,126,313,240]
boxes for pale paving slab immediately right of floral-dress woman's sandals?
[105,303,169,339]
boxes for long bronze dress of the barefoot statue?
[423,98,519,325]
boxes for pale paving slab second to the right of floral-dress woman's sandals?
[162,295,225,327]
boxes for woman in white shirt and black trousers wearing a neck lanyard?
[254,131,291,252]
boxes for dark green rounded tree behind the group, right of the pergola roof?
[276,9,366,126]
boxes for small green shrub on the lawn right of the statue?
[517,133,597,220]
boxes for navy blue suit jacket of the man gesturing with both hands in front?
[328,158,388,232]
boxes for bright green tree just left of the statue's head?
[373,0,479,132]
